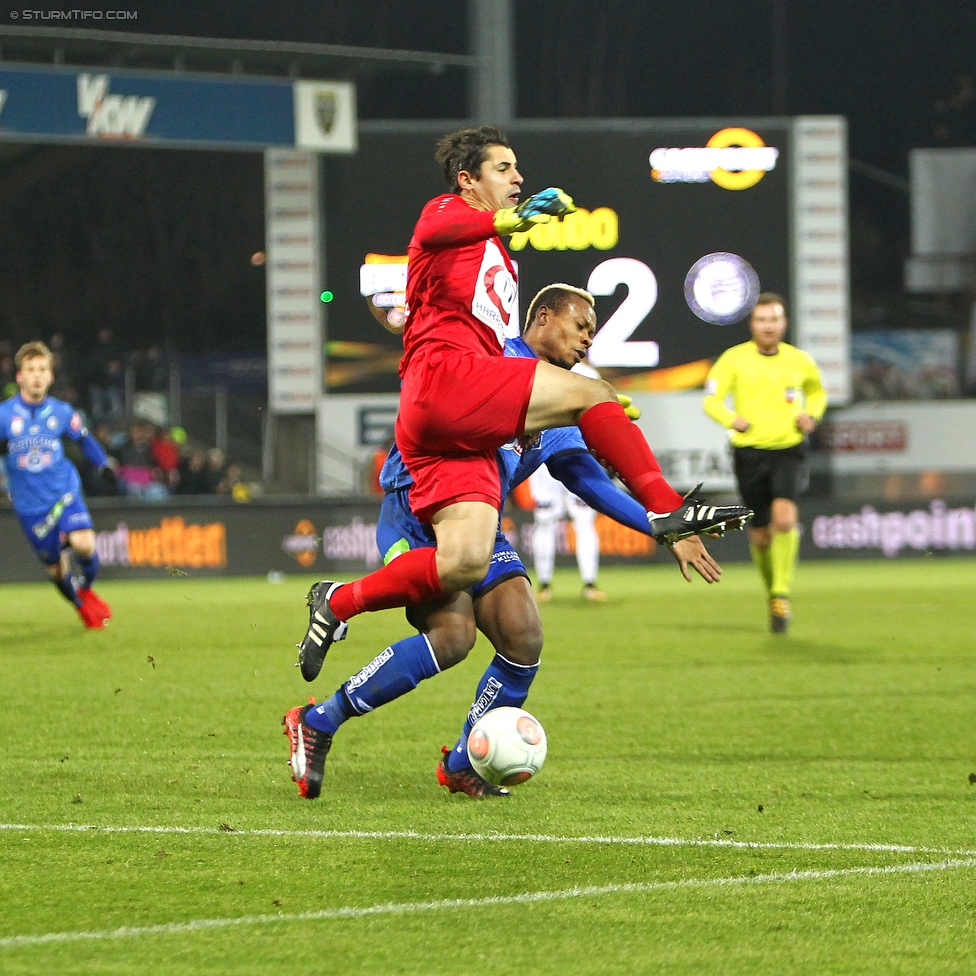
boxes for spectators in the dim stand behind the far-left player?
[0,328,243,500]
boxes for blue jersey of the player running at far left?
[0,394,108,515]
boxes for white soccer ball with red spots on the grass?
[468,706,547,786]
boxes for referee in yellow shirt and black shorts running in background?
[705,292,827,634]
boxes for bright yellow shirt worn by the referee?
[705,340,827,451]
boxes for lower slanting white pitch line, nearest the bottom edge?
[0,858,976,949]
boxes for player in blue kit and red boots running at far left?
[0,342,112,628]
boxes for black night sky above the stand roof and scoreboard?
[95,0,976,162]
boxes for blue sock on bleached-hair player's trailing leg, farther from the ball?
[305,634,440,732]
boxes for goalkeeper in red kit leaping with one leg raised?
[299,126,751,681]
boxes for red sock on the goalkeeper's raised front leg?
[579,400,682,512]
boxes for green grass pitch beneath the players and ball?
[0,560,976,976]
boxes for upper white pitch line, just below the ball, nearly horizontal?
[0,824,976,857]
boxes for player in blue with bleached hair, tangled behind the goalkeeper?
[283,284,721,799]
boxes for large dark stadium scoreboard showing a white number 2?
[322,119,847,393]
